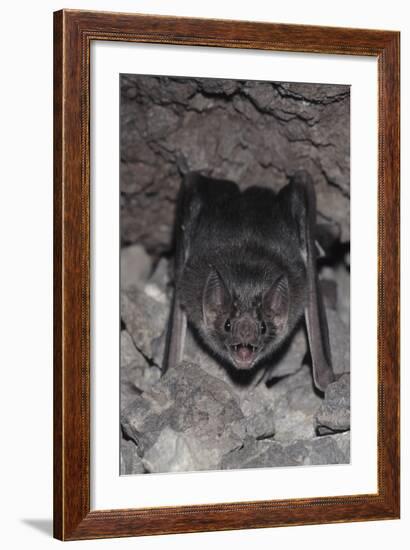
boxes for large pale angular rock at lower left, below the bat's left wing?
[121,362,243,472]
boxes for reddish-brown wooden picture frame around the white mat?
[54,10,400,540]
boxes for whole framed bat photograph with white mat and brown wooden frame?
[54,10,400,540]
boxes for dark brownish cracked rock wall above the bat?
[120,75,350,255]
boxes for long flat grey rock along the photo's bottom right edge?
[221,432,350,470]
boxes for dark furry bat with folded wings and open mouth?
[165,171,334,391]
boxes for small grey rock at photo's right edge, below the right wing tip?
[316,374,350,434]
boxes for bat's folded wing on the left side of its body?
[163,173,205,373]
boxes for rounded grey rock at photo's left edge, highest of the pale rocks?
[121,244,152,290]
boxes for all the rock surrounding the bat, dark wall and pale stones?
[120,75,350,474]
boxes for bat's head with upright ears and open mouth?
[202,268,289,370]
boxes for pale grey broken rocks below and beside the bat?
[121,245,350,474]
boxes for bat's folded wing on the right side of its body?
[288,171,334,391]
